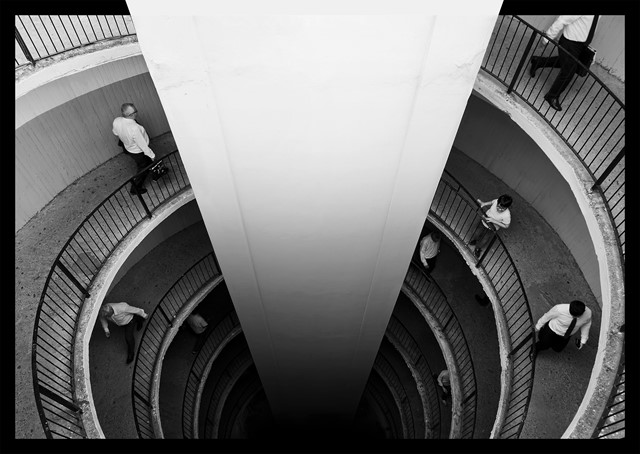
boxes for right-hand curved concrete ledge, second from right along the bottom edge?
[427,213,512,438]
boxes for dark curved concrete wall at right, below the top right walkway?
[454,92,602,304]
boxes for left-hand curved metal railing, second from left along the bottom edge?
[131,252,222,438]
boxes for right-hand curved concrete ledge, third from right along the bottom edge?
[402,282,462,439]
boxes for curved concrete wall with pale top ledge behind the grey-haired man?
[15,44,169,232]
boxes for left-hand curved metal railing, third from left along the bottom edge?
[182,311,240,438]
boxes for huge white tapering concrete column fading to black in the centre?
[127,0,501,432]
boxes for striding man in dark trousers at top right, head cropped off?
[529,16,595,110]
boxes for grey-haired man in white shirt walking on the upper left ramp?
[112,103,156,194]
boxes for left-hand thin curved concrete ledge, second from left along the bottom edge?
[150,275,224,438]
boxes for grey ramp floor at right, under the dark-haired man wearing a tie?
[446,148,601,438]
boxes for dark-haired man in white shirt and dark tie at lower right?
[535,300,591,352]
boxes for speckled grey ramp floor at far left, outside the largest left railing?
[14,132,176,438]
